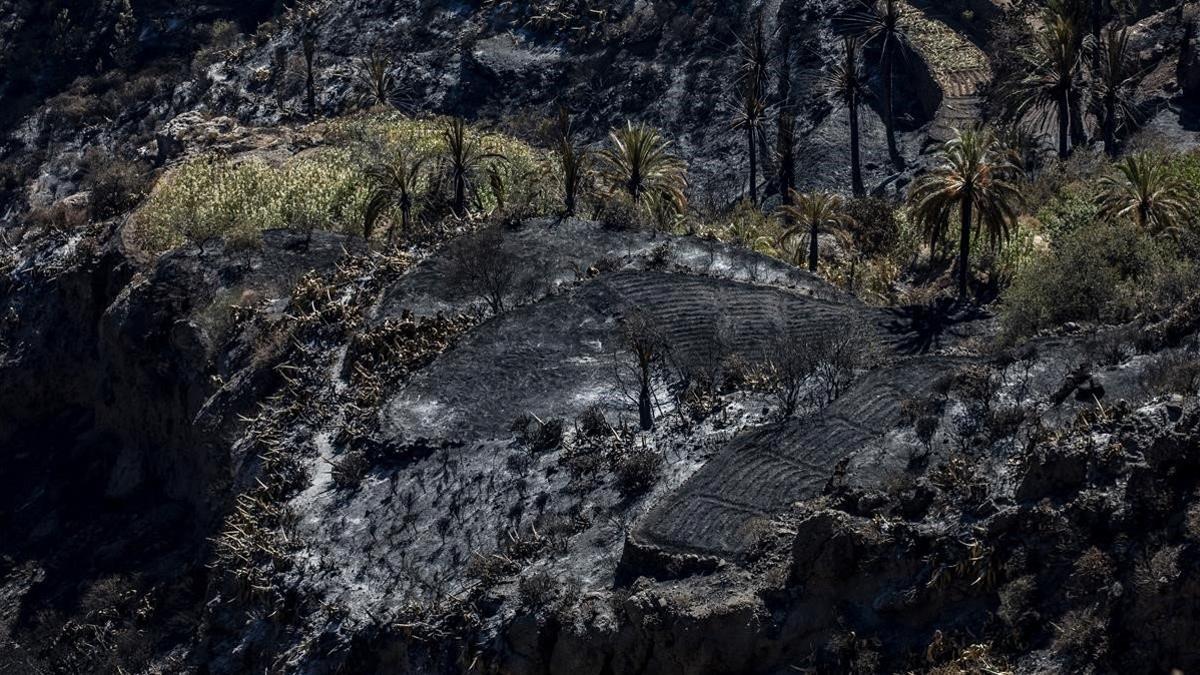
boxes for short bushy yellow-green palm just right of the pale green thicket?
[600,123,688,208]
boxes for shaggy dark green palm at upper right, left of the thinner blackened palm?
[1008,12,1092,159]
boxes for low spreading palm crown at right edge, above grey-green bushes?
[1100,153,1196,235]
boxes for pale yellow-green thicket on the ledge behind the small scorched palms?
[131,113,560,255]
